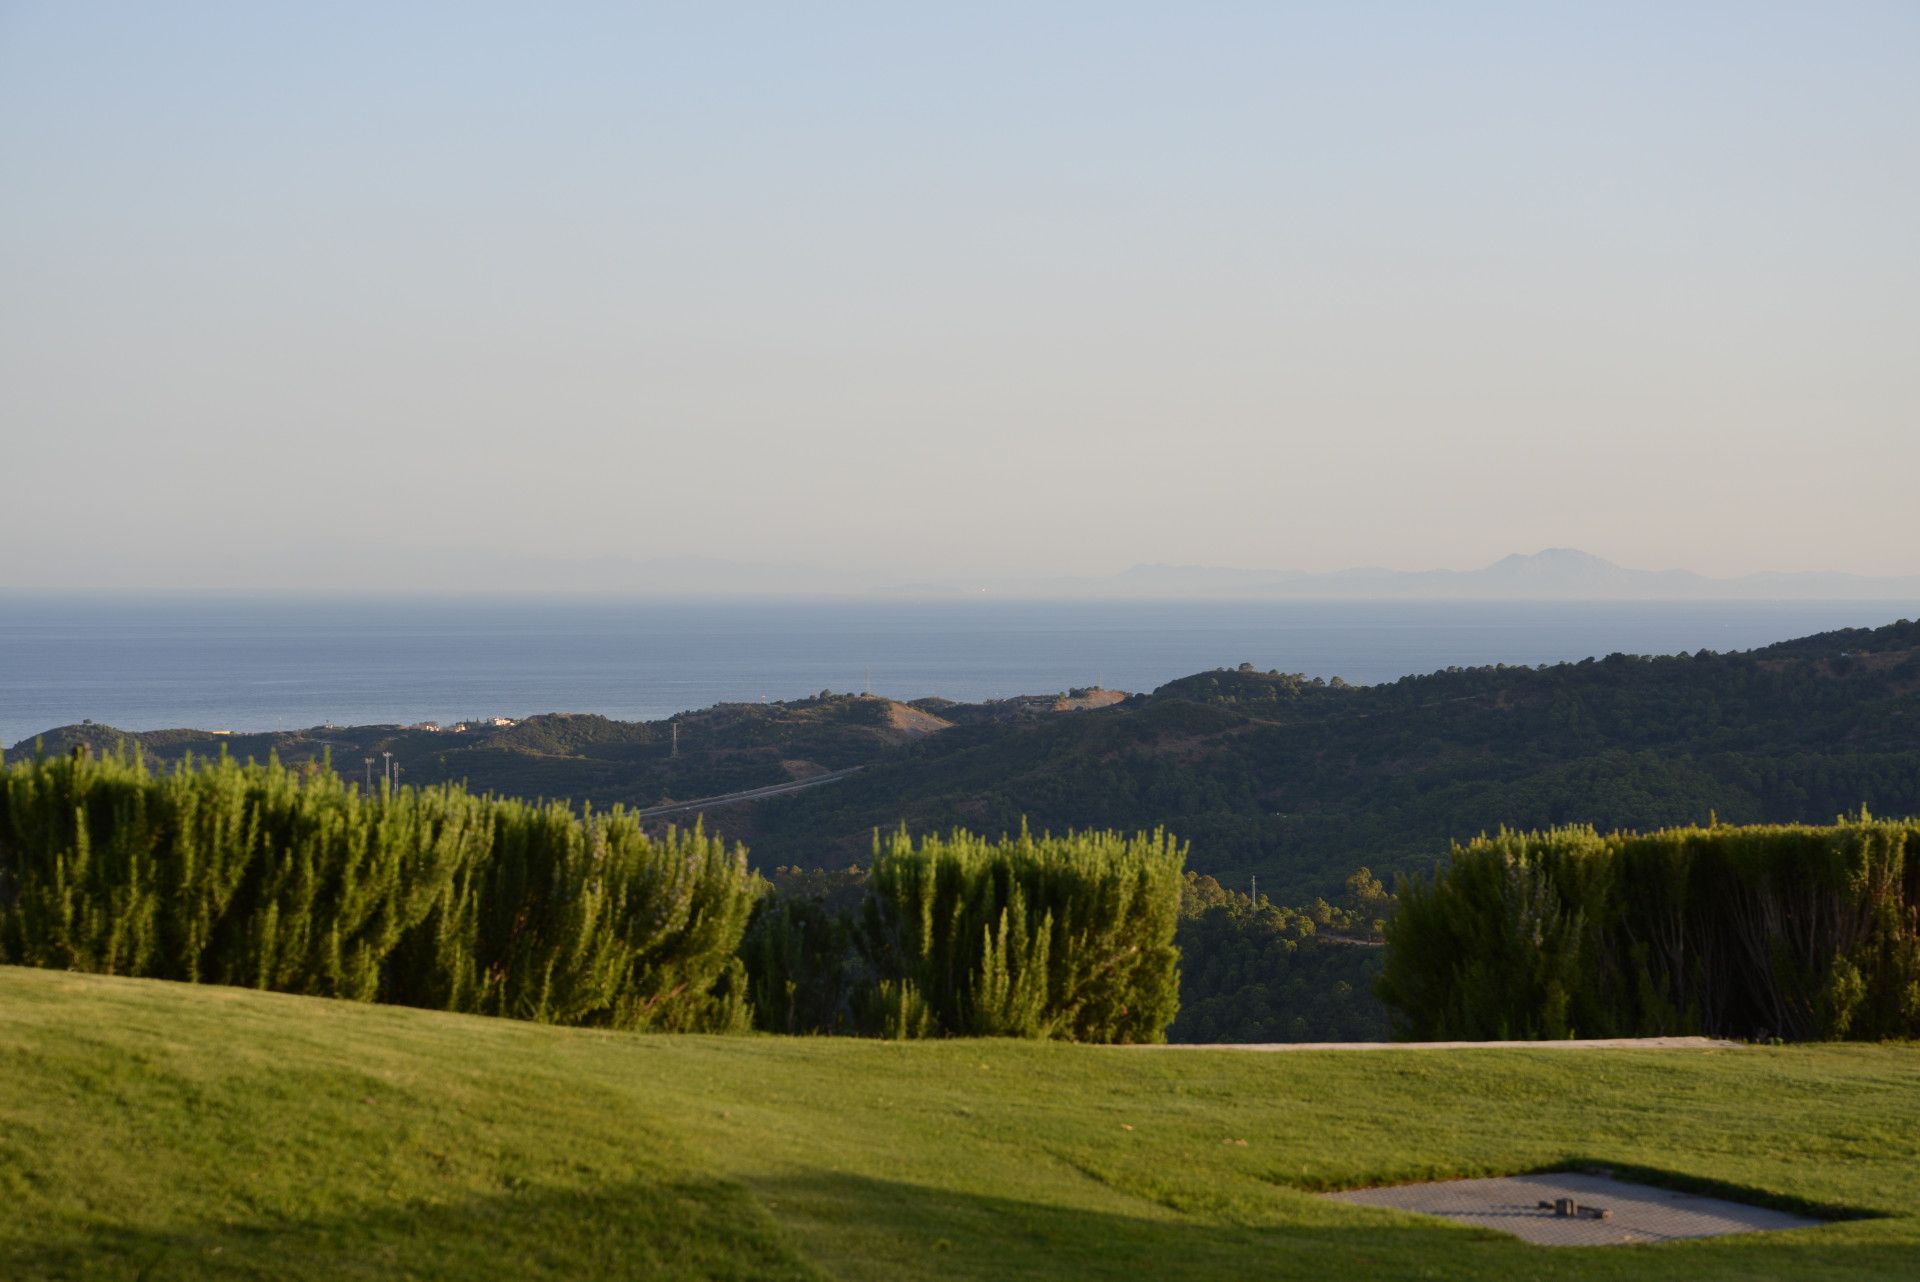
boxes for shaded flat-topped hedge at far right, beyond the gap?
[1379,814,1920,1040]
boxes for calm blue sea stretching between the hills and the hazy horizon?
[0,597,1920,745]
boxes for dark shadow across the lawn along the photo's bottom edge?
[11,1173,1920,1282]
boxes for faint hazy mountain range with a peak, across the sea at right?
[956,547,1920,603]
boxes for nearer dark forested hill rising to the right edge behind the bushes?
[755,622,1920,902]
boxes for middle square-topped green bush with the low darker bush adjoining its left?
[745,831,1187,1042]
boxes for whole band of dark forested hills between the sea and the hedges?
[15,622,1920,902]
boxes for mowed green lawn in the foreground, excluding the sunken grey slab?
[0,969,1920,1282]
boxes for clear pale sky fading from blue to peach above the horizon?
[0,0,1920,589]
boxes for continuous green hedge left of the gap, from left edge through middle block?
[0,750,1185,1042]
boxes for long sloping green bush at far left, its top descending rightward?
[0,752,760,1029]
